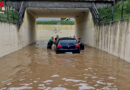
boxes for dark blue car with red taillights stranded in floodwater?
[55,38,80,54]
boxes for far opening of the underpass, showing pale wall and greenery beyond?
[35,17,76,42]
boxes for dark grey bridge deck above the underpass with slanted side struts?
[6,0,116,25]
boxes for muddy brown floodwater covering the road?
[0,42,130,90]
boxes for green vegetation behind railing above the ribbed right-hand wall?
[98,0,130,24]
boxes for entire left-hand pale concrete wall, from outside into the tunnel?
[0,11,35,57]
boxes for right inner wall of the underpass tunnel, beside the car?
[75,11,95,47]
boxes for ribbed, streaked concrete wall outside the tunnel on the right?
[95,20,130,62]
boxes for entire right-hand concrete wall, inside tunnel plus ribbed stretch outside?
[75,12,130,62]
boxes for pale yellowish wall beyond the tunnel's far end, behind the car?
[36,25,75,41]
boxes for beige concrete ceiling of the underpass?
[27,8,89,18]
